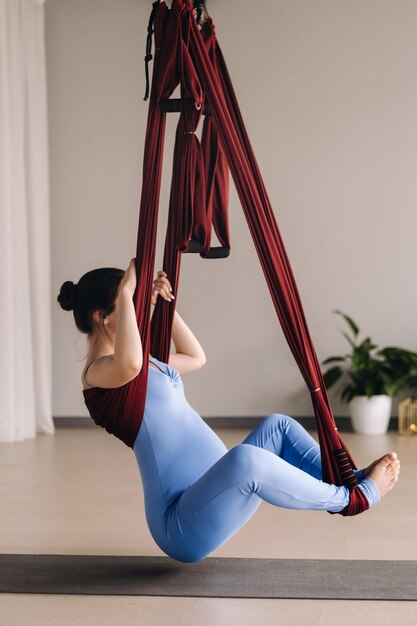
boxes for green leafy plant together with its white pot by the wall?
[322,311,417,435]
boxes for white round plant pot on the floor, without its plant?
[349,395,392,435]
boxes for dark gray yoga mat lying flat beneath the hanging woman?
[0,554,417,600]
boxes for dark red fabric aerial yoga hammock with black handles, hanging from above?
[84,0,369,515]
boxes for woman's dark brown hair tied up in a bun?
[57,267,125,334]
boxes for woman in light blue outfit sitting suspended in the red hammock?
[58,259,400,562]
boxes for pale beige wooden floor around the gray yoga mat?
[0,428,417,626]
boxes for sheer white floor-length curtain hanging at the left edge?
[0,0,54,442]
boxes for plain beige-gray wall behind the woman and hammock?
[46,0,417,416]
